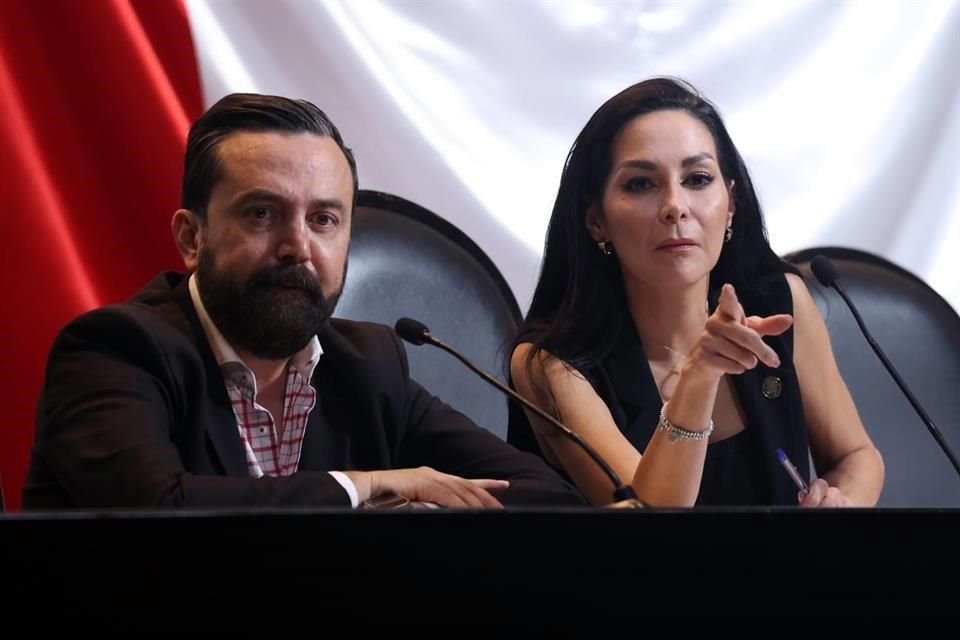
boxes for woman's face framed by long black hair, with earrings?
[587,111,734,287]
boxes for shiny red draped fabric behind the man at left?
[0,0,203,509]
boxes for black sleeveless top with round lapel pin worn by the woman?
[507,274,810,505]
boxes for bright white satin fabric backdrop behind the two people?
[188,0,960,310]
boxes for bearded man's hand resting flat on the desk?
[344,467,510,509]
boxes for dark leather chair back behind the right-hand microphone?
[784,247,960,507]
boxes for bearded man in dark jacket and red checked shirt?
[23,94,582,509]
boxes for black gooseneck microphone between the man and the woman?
[394,318,645,509]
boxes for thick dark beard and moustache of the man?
[197,247,347,360]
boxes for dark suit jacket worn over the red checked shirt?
[23,272,583,509]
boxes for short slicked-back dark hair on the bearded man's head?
[180,93,359,220]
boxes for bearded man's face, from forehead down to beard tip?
[188,132,353,359]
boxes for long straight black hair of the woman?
[514,78,795,376]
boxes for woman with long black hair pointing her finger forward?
[508,78,883,507]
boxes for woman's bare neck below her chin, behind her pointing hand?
[627,278,708,361]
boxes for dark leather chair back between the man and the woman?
[335,190,521,439]
